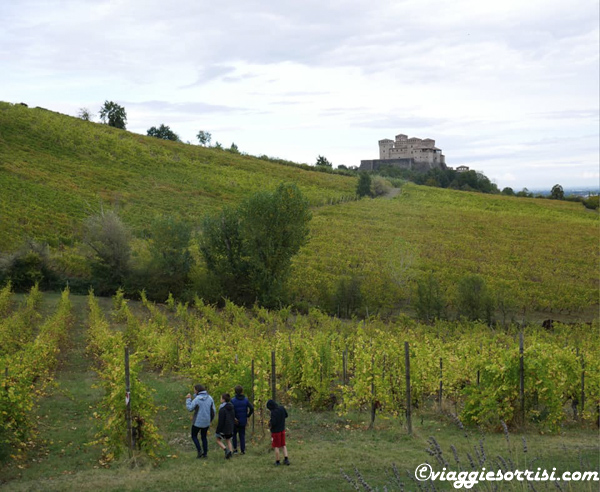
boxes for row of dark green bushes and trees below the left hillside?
[0,183,311,307]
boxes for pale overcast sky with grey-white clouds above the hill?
[0,0,600,189]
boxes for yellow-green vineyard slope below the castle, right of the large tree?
[292,185,599,319]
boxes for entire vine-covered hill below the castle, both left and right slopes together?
[0,103,600,320]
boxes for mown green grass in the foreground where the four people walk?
[0,295,600,491]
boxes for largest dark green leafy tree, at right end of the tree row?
[200,184,311,307]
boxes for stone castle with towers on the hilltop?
[360,133,446,172]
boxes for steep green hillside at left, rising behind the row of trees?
[0,102,356,249]
